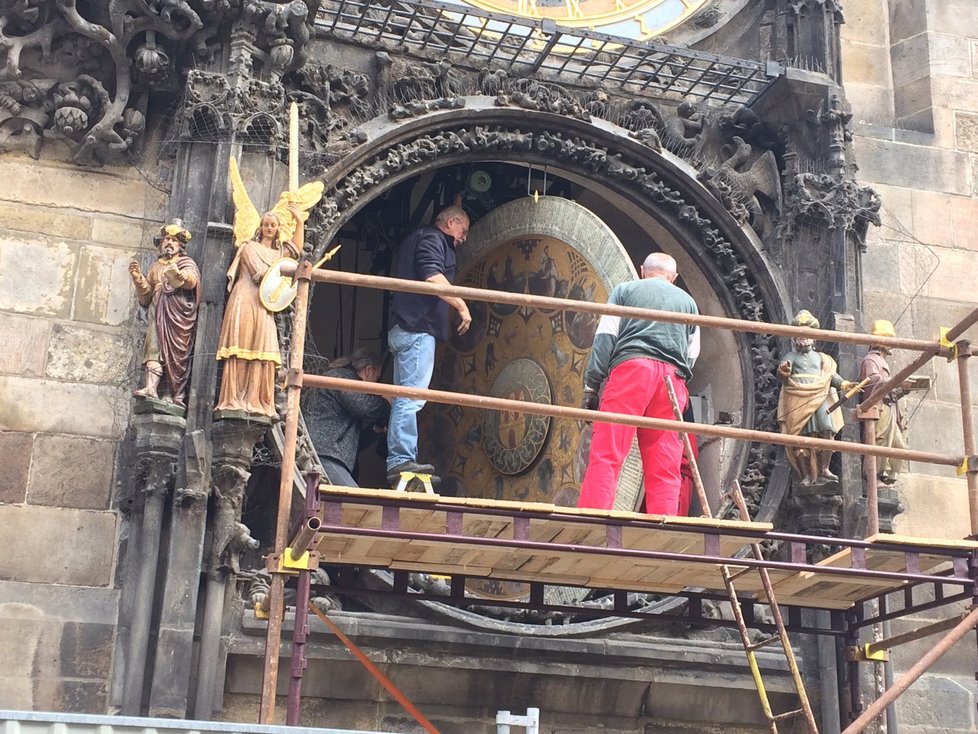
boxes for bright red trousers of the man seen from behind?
[577,358,689,515]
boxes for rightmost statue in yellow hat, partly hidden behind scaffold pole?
[859,319,914,484]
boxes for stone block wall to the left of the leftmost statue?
[0,154,164,713]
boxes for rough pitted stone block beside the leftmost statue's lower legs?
[44,323,133,387]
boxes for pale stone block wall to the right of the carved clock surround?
[842,0,978,734]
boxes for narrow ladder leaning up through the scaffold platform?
[665,375,818,734]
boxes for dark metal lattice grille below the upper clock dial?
[316,0,781,105]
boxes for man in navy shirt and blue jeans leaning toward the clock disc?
[387,206,472,484]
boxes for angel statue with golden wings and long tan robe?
[215,157,323,419]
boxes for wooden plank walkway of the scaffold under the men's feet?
[316,485,978,609]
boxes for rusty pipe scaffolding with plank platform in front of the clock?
[260,262,978,734]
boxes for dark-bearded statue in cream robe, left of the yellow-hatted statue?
[778,309,855,486]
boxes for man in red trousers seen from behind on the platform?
[577,252,700,515]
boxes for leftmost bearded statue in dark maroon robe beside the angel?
[129,219,200,408]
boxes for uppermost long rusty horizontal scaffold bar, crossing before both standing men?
[290,265,936,358]
